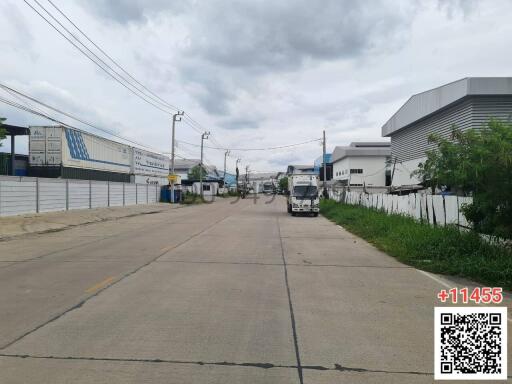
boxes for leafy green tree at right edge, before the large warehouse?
[413,120,512,238]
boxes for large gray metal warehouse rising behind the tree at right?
[382,77,512,189]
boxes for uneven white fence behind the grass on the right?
[330,190,472,227]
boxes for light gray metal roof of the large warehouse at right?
[382,77,512,137]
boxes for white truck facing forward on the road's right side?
[286,173,320,216]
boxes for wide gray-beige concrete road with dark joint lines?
[0,198,510,384]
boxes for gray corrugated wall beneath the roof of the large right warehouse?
[391,96,512,161]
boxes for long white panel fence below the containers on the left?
[0,176,160,216]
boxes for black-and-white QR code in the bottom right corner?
[434,307,507,380]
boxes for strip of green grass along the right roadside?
[320,200,512,290]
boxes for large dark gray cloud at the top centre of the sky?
[187,0,414,71]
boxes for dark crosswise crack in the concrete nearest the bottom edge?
[0,353,434,376]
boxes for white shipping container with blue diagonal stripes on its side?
[29,126,132,174]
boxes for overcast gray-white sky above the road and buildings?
[0,0,512,171]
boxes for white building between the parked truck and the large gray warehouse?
[332,142,391,188]
